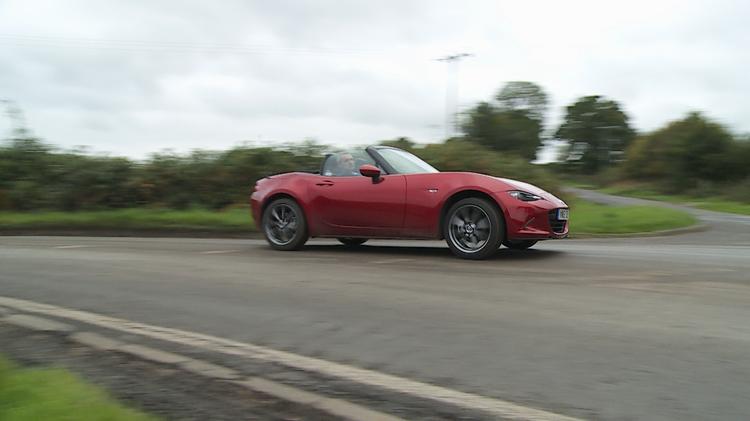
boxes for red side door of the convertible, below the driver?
[311,174,406,236]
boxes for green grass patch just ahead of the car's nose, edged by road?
[569,199,696,236]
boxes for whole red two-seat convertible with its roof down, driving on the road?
[250,146,569,259]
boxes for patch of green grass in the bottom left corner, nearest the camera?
[0,357,157,421]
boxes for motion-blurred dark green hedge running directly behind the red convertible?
[0,138,559,211]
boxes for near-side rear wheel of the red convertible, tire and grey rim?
[261,197,308,251]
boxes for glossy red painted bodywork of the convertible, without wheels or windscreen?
[250,167,568,240]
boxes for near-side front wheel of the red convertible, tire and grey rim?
[443,197,505,260]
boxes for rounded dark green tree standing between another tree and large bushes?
[555,95,635,174]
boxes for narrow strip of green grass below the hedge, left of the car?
[0,207,255,231]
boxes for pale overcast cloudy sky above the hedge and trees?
[0,0,750,157]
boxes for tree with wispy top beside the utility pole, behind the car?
[463,82,547,160]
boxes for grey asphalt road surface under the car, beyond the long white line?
[0,192,750,420]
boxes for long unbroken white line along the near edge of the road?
[0,296,578,421]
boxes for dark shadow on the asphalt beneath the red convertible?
[303,244,565,261]
